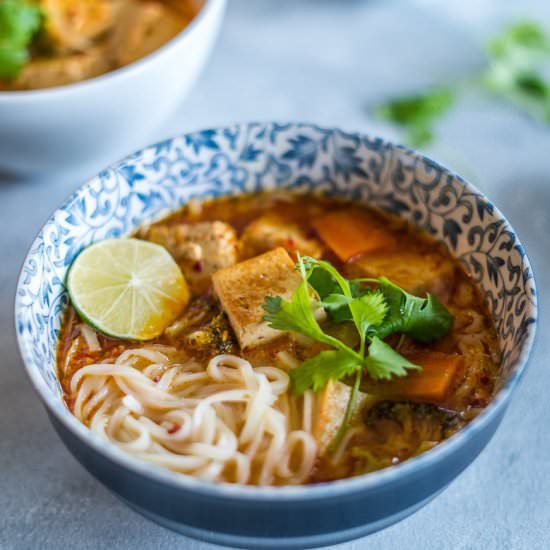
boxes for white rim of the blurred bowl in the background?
[0,0,227,105]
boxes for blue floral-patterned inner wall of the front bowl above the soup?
[15,123,536,444]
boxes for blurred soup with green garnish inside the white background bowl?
[0,0,200,91]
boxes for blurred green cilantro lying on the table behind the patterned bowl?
[375,21,550,147]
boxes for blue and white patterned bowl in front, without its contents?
[15,123,537,548]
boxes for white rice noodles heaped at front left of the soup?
[70,346,317,485]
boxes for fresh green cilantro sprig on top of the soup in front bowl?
[263,257,453,445]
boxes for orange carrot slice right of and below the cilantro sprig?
[368,351,463,401]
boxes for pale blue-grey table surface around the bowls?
[0,0,550,550]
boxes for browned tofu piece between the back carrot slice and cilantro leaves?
[355,251,454,299]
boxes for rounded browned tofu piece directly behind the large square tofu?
[241,214,323,258]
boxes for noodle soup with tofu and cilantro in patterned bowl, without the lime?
[58,193,500,485]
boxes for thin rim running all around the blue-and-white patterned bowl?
[14,121,538,502]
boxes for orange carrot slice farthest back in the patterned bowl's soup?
[313,210,395,262]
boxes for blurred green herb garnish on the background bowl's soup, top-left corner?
[0,0,42,79]
